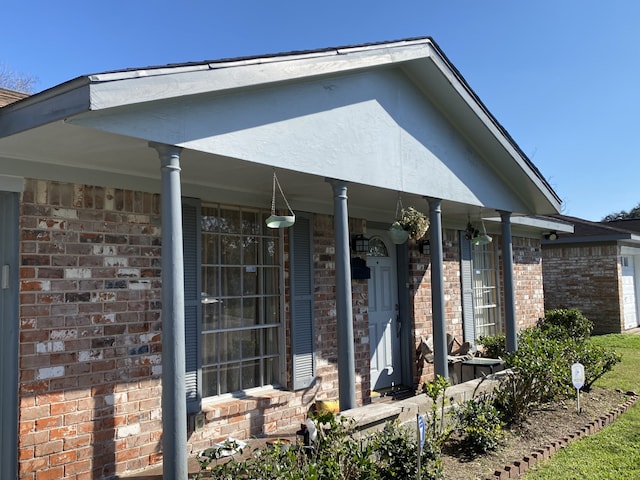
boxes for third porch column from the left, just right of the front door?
[426,198,449,379]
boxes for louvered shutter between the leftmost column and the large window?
[182,199,202,413]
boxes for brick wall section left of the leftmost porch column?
[19,180,161,479]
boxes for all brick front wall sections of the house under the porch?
[13,180,542,480]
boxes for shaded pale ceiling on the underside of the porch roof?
[0,121,480,223]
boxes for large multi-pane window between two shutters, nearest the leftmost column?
[200,205,283,398]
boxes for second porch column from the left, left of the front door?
[327,179,356,410]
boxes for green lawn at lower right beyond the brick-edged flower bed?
[523,335,640,480]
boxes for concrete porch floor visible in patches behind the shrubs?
[117,372,501,480]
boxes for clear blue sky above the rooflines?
[0,0,640,220]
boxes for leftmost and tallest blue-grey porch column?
[149,143,189,480]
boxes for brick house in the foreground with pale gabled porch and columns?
[0,38,570,479]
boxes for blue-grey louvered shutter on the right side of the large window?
[289,214,315,390]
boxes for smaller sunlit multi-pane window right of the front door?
[471,243,501,338]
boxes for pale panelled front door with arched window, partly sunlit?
[367,232,402,390]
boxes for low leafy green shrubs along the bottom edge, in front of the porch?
[192,413,444,480]
